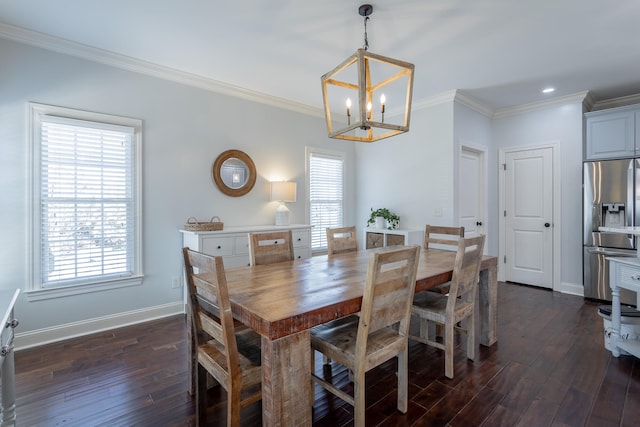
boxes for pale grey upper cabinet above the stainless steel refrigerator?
[584,105,640,160]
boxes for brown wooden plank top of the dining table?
[226,248,497,340]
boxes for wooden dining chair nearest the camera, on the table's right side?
[311,245,420,427]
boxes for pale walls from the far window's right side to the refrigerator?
[356,92,583,289]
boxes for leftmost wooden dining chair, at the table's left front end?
[183,248,262,426]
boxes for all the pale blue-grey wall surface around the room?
[0,35,582,346]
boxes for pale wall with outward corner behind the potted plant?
[356,97,498,255]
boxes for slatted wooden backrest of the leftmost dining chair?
[183,248,240,377]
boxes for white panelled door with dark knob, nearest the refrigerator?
[504,148,553,288]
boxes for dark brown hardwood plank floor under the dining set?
[15,283,640,427]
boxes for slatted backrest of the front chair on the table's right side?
[356,245,420,351]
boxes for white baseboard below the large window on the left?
[14,301,184,351]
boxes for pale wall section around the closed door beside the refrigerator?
[493,100,583,288]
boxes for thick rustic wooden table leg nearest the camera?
[262,330,313,426]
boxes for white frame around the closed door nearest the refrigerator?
[498,141,562,291]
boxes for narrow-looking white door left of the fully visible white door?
[458,147,485,237]
